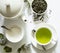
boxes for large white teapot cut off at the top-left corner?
[0,0,24,19]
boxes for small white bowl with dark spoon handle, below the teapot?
[5,25,24,43]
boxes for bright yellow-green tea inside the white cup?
[36,28,52,44]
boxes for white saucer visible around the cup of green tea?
[32,23,57,50]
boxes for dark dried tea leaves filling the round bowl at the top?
[32,0,47,14]
